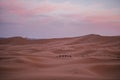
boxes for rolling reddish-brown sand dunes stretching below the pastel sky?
[0,34,120,80]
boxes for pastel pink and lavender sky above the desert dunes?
[0,0,120,38]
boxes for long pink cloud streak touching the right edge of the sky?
[85,14,120,27]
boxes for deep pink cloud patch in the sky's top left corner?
[0,0,30,16]
